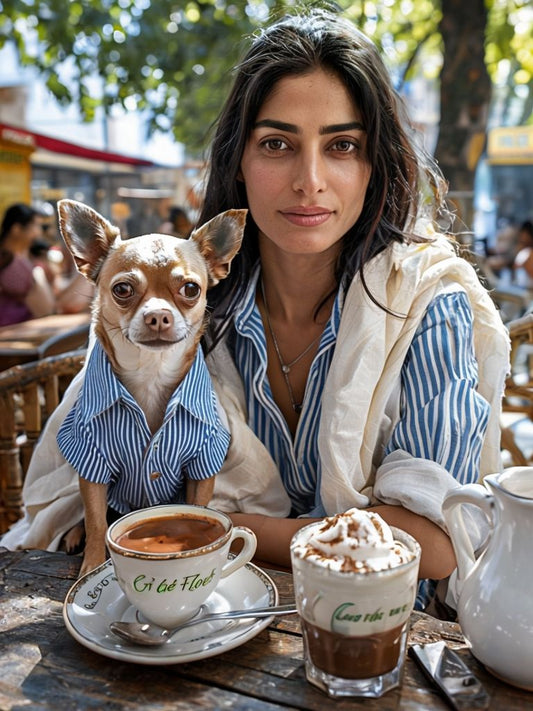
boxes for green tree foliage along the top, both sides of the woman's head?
[0,0,533,143]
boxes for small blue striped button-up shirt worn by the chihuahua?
[57,342,230,513]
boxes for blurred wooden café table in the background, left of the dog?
[0,313,91,370]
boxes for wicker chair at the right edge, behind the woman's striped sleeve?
[502,313,533,466]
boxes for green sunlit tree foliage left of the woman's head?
[0,0,287,153]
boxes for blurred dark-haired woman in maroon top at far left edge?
[0,203,54,326]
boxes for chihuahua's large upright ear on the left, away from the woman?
[57,200,120,282]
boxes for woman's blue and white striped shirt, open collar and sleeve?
[234,264,489,516]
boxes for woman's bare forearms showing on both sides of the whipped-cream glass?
[231,504,456,579]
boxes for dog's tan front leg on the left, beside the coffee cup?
[80,477,107,576]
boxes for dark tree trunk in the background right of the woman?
[435,0,491,236]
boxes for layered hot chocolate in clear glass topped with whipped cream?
[291,509,421,698]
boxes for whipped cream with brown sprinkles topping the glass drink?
[293,509,415,573]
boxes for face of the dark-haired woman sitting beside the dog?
[241,69,371,254]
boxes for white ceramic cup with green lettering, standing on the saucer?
[106,504,257,627]
